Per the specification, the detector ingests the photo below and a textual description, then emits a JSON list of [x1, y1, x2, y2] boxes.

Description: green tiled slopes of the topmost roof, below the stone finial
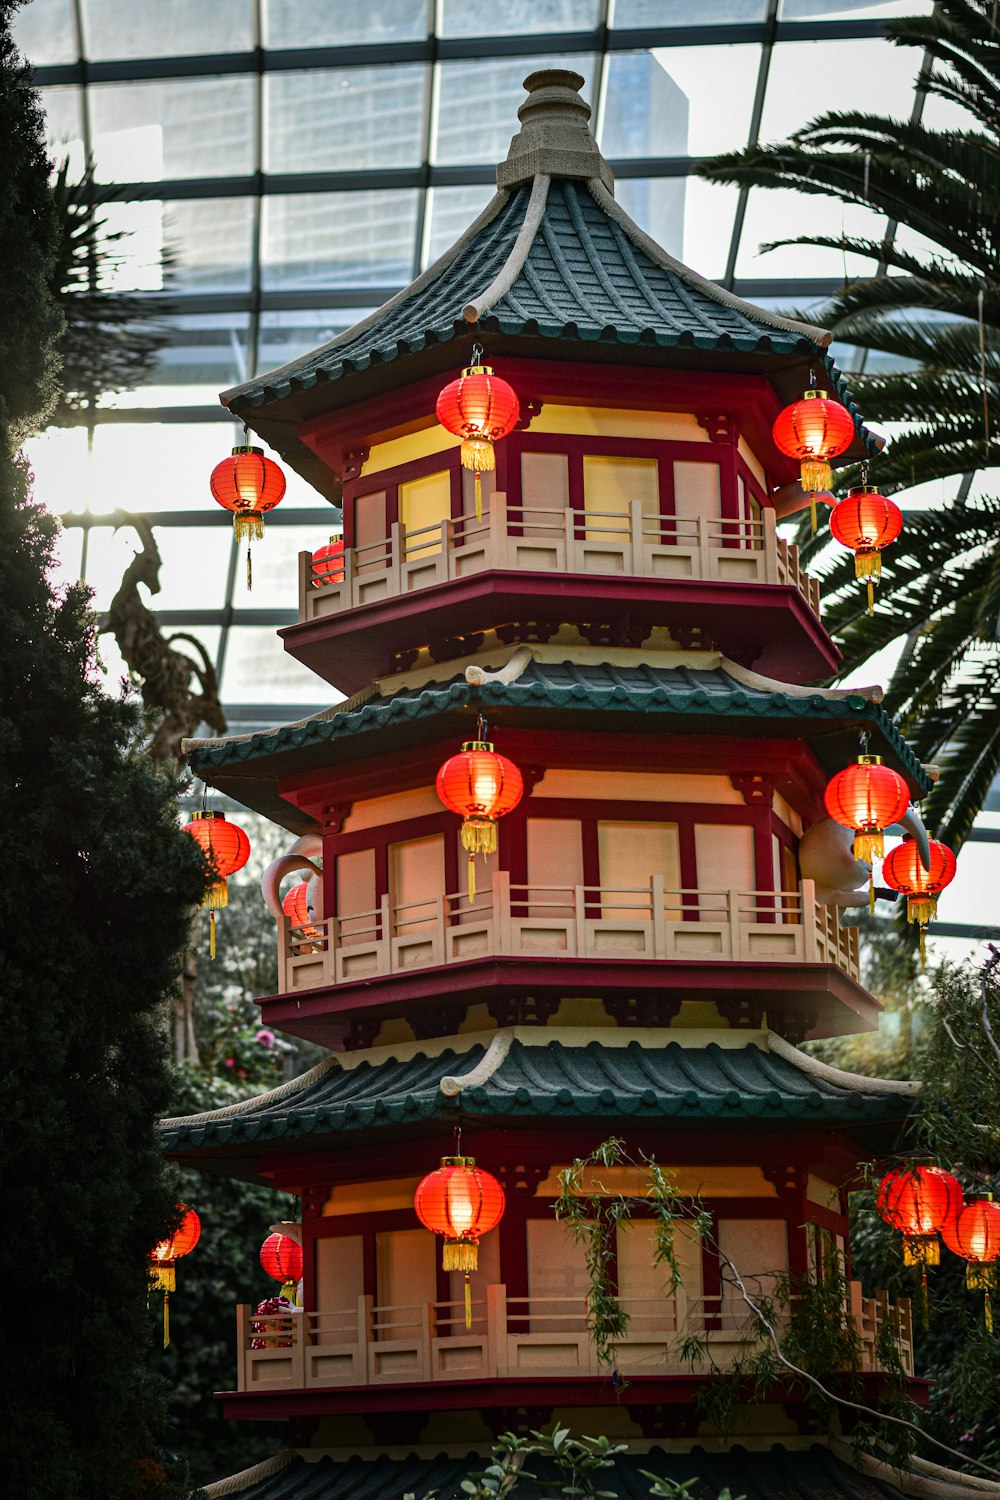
[[222, 180, 861, 431]]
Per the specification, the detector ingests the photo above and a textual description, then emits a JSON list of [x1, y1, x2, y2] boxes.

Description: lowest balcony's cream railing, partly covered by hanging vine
[[237, 1281, 913, 1391]]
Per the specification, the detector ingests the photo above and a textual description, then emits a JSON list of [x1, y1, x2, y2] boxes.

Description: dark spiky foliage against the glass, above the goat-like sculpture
[[51, 162, 169, 425]]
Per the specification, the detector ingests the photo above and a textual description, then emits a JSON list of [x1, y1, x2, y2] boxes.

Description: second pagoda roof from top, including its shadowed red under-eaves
[[184, 656, 931, 831]]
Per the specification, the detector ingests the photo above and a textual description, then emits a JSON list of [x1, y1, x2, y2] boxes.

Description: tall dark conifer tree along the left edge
[[0, 0, 204, 1500]]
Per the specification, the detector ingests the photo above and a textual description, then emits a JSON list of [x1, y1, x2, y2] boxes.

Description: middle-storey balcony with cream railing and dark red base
[[261, 870, 879, 1047]]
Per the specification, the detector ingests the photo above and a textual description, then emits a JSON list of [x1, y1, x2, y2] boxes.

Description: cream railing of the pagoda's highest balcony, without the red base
[[298, 494, 820, 624]]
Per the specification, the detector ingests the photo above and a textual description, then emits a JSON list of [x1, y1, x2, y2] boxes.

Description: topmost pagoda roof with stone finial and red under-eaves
[[220, 69, 867, 498]]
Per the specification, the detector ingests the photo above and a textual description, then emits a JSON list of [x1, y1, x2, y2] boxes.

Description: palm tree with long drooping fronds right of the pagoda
[[700, 0, 1000, 848]]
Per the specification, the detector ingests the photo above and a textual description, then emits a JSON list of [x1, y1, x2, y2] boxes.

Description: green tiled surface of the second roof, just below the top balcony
[[189, 662, 930, 792]]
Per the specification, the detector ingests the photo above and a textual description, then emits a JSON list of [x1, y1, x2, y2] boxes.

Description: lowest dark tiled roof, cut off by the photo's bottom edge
[[207, 1443, 917, 1500]]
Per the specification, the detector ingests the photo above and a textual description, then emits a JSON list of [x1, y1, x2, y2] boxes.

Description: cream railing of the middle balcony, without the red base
[[279, 870, 861, 995]]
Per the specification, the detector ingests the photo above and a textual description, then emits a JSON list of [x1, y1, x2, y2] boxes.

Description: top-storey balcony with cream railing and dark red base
[[283, 494, 838, 692]]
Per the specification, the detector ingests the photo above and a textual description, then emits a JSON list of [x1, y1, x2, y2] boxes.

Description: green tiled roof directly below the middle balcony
[[162, 1041, 910, 1154]]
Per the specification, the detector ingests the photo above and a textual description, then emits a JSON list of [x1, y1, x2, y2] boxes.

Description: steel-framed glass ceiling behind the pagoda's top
[[15, 0, 930, 731]]
